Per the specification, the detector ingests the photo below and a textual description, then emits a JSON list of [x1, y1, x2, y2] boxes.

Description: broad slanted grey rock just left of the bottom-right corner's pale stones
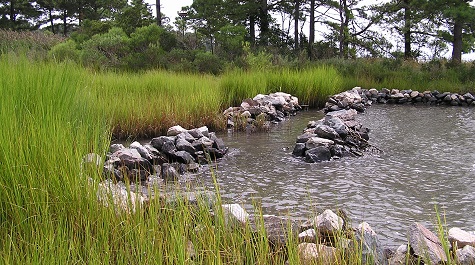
[[409, 223, 447, 264]]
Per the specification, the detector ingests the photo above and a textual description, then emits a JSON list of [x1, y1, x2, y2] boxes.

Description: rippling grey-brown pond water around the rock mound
[[208, 105, 475, 247]]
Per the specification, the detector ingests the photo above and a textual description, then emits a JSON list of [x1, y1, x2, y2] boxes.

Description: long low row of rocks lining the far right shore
[[324, 87, 475, 112]]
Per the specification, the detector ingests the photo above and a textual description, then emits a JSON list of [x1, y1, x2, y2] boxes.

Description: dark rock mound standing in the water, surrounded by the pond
[[292, 109, 370, 163]]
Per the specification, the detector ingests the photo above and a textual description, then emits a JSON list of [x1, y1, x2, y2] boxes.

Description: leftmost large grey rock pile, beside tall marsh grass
[[104, 125, 228, 182]]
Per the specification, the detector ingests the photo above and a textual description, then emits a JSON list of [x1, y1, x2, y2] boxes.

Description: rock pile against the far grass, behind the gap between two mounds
[[223, 92, 302, 130]]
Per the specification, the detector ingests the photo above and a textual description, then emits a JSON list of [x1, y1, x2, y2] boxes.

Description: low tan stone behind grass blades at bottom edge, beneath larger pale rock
[[297, 243, 337, 265]]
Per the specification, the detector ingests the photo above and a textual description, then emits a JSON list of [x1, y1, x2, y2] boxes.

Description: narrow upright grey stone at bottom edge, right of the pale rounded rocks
[[355, 222, 388, 265]]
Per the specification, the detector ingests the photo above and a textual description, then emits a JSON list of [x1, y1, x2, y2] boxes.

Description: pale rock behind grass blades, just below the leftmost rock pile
[[97, 180, 147, 214]]
